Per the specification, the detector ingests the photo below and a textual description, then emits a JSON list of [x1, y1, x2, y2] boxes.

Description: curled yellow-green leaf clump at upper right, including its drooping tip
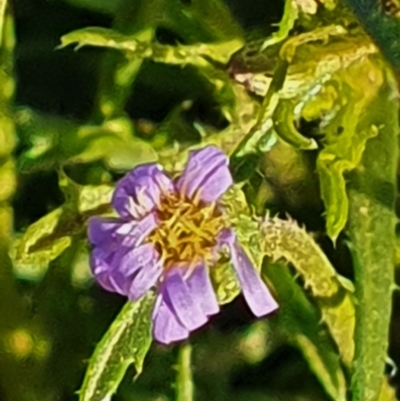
[[236, 25, 382, 241]]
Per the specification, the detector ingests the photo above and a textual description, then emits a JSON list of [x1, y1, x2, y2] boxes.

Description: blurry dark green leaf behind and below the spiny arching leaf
[[262, 263, 347, 401]]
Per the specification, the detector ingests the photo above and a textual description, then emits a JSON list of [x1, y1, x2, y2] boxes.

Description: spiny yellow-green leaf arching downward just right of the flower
[[261, 217, 355, 366]]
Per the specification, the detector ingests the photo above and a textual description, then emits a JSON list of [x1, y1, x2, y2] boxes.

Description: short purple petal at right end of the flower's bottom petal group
[[186, 266, 219, 316]]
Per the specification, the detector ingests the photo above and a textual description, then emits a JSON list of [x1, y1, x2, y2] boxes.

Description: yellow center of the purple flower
[[148, 194, 225, 270]]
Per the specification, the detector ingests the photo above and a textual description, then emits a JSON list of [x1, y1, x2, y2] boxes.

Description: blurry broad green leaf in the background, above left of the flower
[[16, 108, 157, 172]]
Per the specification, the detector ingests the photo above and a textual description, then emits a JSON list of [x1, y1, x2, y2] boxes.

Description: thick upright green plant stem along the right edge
[[348, 66, 399, 401]]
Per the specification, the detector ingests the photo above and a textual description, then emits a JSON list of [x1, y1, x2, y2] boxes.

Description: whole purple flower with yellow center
[[89, 146, 277, 344]]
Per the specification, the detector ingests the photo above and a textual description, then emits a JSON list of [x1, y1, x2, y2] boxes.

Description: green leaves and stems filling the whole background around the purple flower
[[0, 0, 399, 401]]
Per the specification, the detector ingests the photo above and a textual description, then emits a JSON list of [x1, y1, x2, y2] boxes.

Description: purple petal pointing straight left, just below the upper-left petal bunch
[[88, 213, 157, 250]]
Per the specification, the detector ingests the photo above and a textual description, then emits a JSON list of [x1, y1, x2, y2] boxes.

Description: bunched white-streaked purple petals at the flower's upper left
[[112, 163, 174, 219]]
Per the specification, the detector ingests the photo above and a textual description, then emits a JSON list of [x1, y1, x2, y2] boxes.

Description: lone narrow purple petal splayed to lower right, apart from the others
[[220, 230, 278, 317]]
